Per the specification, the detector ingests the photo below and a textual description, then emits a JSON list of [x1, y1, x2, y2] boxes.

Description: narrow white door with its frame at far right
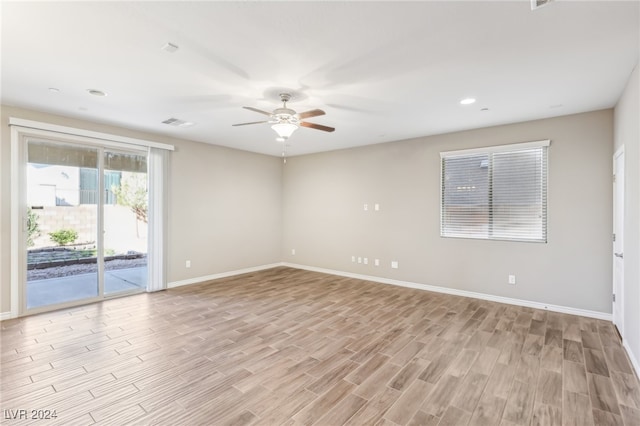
[[611, 145, 625, 337]]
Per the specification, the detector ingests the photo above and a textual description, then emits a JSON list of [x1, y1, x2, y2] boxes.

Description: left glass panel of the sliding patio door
[[26, 141, 100, 309]]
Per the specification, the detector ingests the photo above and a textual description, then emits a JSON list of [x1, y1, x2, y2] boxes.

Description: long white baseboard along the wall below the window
[[283, 262, 612, 321]]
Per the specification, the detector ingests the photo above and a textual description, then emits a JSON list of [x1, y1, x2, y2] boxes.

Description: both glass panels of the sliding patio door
[[23, 139, 148, 311]]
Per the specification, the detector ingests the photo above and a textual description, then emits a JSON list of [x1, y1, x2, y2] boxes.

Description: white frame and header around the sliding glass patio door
[[9, 118, 160, 318]]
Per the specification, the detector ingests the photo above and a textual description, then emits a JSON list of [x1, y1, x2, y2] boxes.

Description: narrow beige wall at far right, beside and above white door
[[614, 65, 640, 373]]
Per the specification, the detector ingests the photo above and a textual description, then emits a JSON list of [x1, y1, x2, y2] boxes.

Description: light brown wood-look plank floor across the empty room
[[0, 268, 640, 426]]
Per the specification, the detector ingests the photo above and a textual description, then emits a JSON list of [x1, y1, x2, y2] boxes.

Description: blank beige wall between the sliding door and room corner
[[167, 136, 282, 281]]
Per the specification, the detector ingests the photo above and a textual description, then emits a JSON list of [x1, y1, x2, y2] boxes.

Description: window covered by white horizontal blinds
[[440, 140, 550, 242]]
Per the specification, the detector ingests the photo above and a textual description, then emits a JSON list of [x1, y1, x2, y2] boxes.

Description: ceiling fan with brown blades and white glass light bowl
[[234, 93, 335, 142]]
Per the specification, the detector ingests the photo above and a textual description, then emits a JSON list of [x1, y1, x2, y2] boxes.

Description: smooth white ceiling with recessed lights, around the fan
[[1, 0, 640, 155]]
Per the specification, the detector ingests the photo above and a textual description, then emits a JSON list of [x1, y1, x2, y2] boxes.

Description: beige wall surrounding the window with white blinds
[[283, 110, 613, 313]]
